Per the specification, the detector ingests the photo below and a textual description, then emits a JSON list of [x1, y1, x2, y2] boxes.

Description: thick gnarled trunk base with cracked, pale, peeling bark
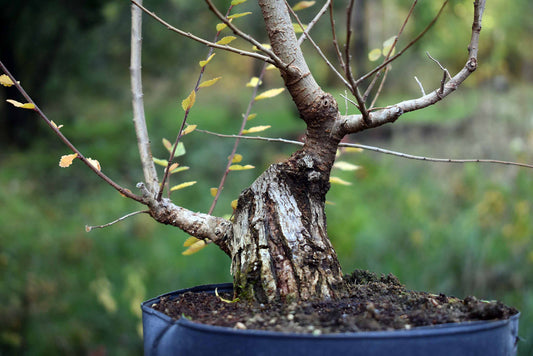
[[229, 140, 343, 302]]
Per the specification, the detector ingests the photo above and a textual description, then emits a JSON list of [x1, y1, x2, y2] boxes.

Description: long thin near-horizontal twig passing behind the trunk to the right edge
[[195, 129, 533, 169]]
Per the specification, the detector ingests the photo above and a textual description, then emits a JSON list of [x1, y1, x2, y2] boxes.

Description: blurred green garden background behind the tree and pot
[[0, 0, 533, 355]]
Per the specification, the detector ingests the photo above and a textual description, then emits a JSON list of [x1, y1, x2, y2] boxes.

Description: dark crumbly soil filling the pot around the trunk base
[[152, 271, 518, 334]]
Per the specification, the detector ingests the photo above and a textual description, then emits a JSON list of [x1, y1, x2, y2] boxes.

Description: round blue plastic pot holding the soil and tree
[[141, 284, 519, 356]]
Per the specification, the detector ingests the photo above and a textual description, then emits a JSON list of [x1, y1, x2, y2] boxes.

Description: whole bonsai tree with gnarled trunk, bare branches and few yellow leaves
[[4, 0, 520, 302]]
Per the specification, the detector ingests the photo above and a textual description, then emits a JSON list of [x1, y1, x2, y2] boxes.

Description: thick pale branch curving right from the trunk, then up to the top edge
[[335, 0, 485, 135]]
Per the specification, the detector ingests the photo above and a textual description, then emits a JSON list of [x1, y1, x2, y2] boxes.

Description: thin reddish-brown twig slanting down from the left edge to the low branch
[[0, 61, 143, 203]]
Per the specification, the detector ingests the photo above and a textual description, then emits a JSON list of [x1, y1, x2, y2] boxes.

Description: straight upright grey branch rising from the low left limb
[[130, 0, 158, 193]]
